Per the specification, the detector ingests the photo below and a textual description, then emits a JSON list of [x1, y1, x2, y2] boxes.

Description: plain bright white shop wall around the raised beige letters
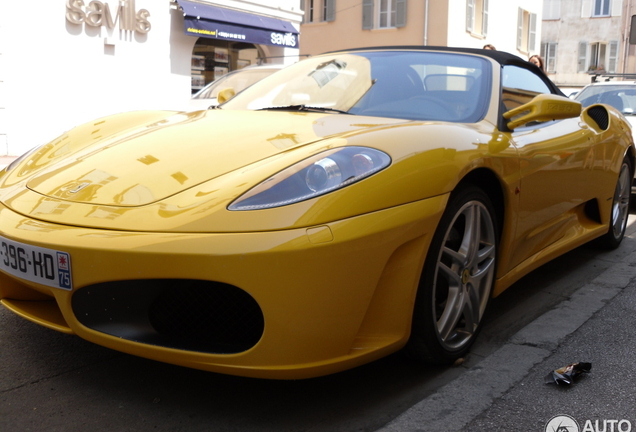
[[0, 0, 301, 155]]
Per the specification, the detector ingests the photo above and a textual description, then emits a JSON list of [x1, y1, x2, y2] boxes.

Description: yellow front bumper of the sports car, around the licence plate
[[0, 195, 447, 379]]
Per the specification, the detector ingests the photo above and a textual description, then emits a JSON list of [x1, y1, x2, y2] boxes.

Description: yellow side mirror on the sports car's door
[[504, 94, 582, 130]]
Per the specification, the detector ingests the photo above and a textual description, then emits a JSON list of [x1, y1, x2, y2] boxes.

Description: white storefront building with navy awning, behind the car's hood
[[0, 0, 303, 155]]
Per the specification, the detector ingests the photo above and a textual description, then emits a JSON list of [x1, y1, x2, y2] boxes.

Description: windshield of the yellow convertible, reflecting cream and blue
[[222, 51, 491, 122]]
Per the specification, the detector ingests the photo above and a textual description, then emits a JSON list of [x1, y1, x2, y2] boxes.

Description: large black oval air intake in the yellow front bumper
[[72, 279, 264, 354]]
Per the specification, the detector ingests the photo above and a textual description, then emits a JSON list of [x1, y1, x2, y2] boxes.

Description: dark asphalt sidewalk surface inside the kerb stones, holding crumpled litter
[[461, 272, 636, 432]]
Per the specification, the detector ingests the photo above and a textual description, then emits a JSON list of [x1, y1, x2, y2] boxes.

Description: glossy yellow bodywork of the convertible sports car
[[0, 47, 634, 379]]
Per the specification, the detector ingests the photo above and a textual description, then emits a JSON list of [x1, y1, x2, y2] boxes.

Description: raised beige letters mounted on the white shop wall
[[66, 0, 152, 34]]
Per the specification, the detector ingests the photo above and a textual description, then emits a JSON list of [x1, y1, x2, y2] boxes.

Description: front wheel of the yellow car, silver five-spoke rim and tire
[[406, 186, 499, 364]]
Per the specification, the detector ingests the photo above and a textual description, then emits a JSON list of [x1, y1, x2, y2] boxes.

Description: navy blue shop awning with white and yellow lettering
[[177, 0, 299, 48]]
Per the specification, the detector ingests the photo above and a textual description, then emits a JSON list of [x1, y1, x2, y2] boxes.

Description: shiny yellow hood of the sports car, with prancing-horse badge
[[4, 110, 399, 207]]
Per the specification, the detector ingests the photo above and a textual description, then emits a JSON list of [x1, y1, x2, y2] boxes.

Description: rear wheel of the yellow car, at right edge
[[599, 156, 634, 249]]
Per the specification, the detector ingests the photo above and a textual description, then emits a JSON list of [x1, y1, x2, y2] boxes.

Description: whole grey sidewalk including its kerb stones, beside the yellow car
[[380, 226, 636, 432]]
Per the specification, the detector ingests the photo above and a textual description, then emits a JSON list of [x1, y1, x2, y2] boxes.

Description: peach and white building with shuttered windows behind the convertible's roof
[[300, 0, 542, 58]]
